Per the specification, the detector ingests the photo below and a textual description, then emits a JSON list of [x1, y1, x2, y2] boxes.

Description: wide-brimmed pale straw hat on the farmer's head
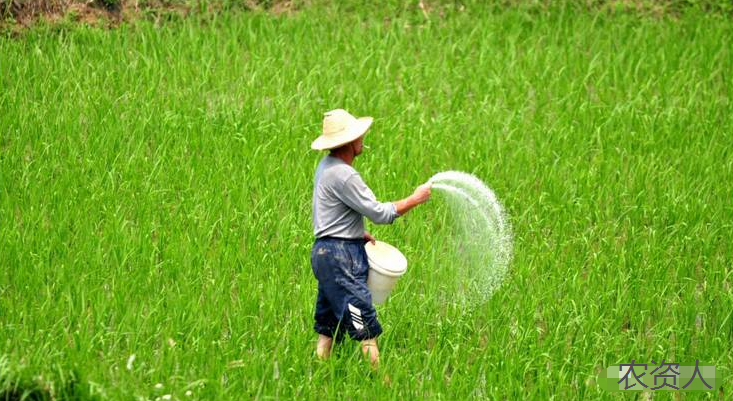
[[311, 109, 372, 150]]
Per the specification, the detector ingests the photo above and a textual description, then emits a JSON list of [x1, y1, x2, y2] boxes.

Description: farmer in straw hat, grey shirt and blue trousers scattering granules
[[311, 109, 431, 366]]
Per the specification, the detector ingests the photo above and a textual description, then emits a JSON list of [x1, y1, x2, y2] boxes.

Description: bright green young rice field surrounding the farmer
[[0, 3, 733, 400]]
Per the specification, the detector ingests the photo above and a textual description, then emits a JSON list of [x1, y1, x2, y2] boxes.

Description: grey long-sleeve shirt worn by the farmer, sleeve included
[[313, 156, 399, 238]]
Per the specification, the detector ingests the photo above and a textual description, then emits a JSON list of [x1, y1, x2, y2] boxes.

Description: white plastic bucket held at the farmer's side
[[364, 241, 407, 304]]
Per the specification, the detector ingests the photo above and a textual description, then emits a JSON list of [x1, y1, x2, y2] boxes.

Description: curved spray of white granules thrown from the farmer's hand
[[429, 171, 512, 299]]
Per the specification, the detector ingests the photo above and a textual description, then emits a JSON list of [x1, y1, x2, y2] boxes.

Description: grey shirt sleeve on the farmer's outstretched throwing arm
[[338, 173, 399, 224]]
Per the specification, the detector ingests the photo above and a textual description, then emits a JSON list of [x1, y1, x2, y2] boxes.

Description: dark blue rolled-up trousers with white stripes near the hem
[[311, 238, 382, 341]]
